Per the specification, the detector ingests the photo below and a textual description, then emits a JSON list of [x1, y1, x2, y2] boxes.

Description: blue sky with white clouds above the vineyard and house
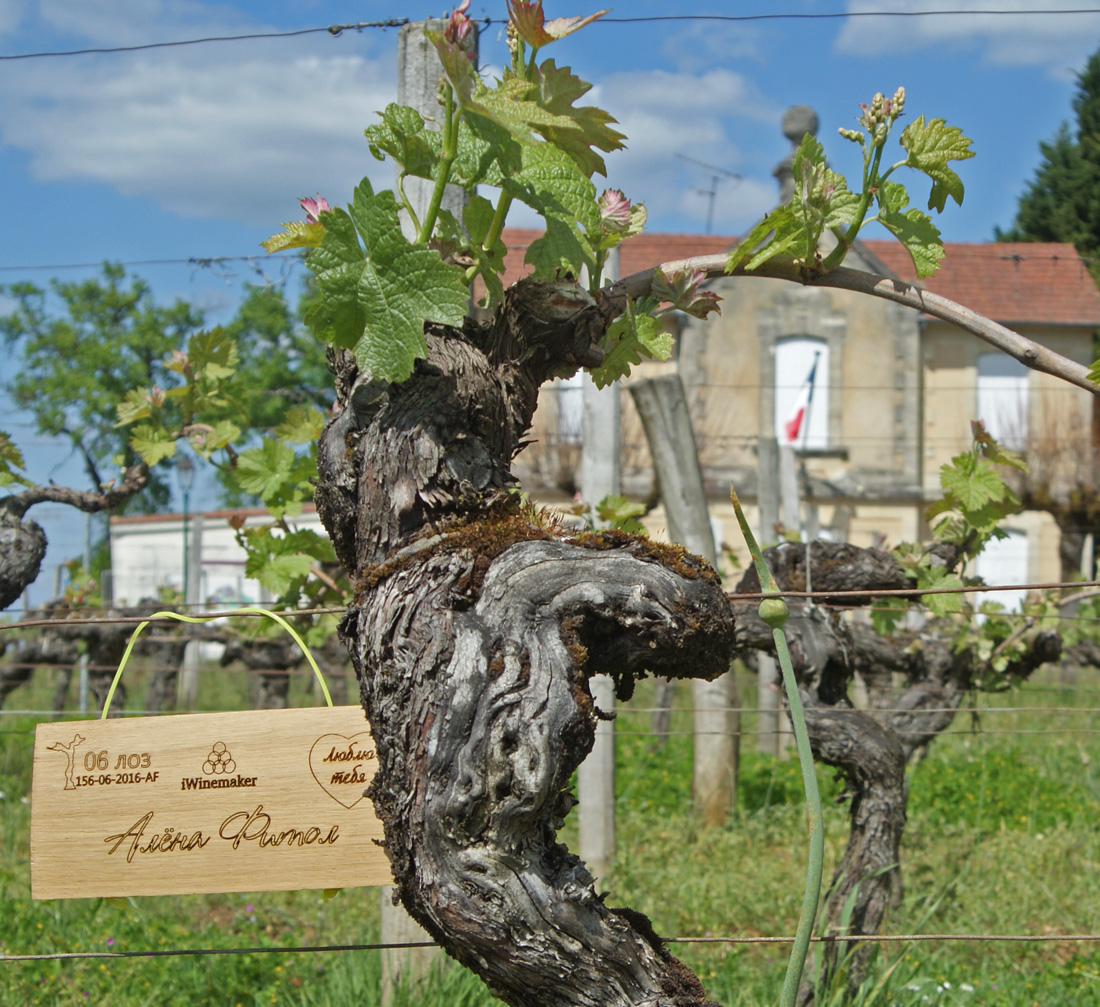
[[0, 0, 1100, 601]]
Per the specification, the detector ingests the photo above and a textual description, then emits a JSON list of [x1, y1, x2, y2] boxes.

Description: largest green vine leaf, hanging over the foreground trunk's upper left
[[306, 178, 469, 382]]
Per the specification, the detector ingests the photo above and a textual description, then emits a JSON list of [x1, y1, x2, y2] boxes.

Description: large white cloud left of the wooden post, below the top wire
[[0, 41, 396, 225]]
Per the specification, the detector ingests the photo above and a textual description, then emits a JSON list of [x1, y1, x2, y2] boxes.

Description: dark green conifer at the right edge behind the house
[[997, 42, 1100, 282]]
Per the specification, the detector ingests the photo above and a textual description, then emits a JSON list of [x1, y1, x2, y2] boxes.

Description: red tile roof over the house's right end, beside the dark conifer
[[860, 240, 1100, 326]]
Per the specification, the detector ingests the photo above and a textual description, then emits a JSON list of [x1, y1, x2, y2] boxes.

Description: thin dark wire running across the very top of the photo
[[0, 7, 1100, 61]]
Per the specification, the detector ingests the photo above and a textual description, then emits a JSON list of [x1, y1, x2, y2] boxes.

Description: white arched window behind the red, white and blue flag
[[776, 336, 829, 450]]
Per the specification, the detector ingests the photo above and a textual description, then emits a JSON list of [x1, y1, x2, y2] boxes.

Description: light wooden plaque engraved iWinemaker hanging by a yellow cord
[[31, 707, 393, 899]]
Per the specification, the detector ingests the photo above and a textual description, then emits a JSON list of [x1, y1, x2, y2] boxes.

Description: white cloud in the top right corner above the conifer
[[834, 0, 1100, 76]]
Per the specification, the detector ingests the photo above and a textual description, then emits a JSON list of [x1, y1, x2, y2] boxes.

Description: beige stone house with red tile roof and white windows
[[505, 234, 1100, 583]]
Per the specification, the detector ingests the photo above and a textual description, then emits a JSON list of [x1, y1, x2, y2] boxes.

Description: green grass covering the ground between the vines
[[0, 669, 1100, 1007]]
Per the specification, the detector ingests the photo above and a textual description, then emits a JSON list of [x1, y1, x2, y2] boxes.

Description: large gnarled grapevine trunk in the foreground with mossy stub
[[317, 281, 733, 1007]]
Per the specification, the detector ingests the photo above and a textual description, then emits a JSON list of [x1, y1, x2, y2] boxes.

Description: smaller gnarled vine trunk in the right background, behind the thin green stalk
[[734, 541, 1062, 1005]]
